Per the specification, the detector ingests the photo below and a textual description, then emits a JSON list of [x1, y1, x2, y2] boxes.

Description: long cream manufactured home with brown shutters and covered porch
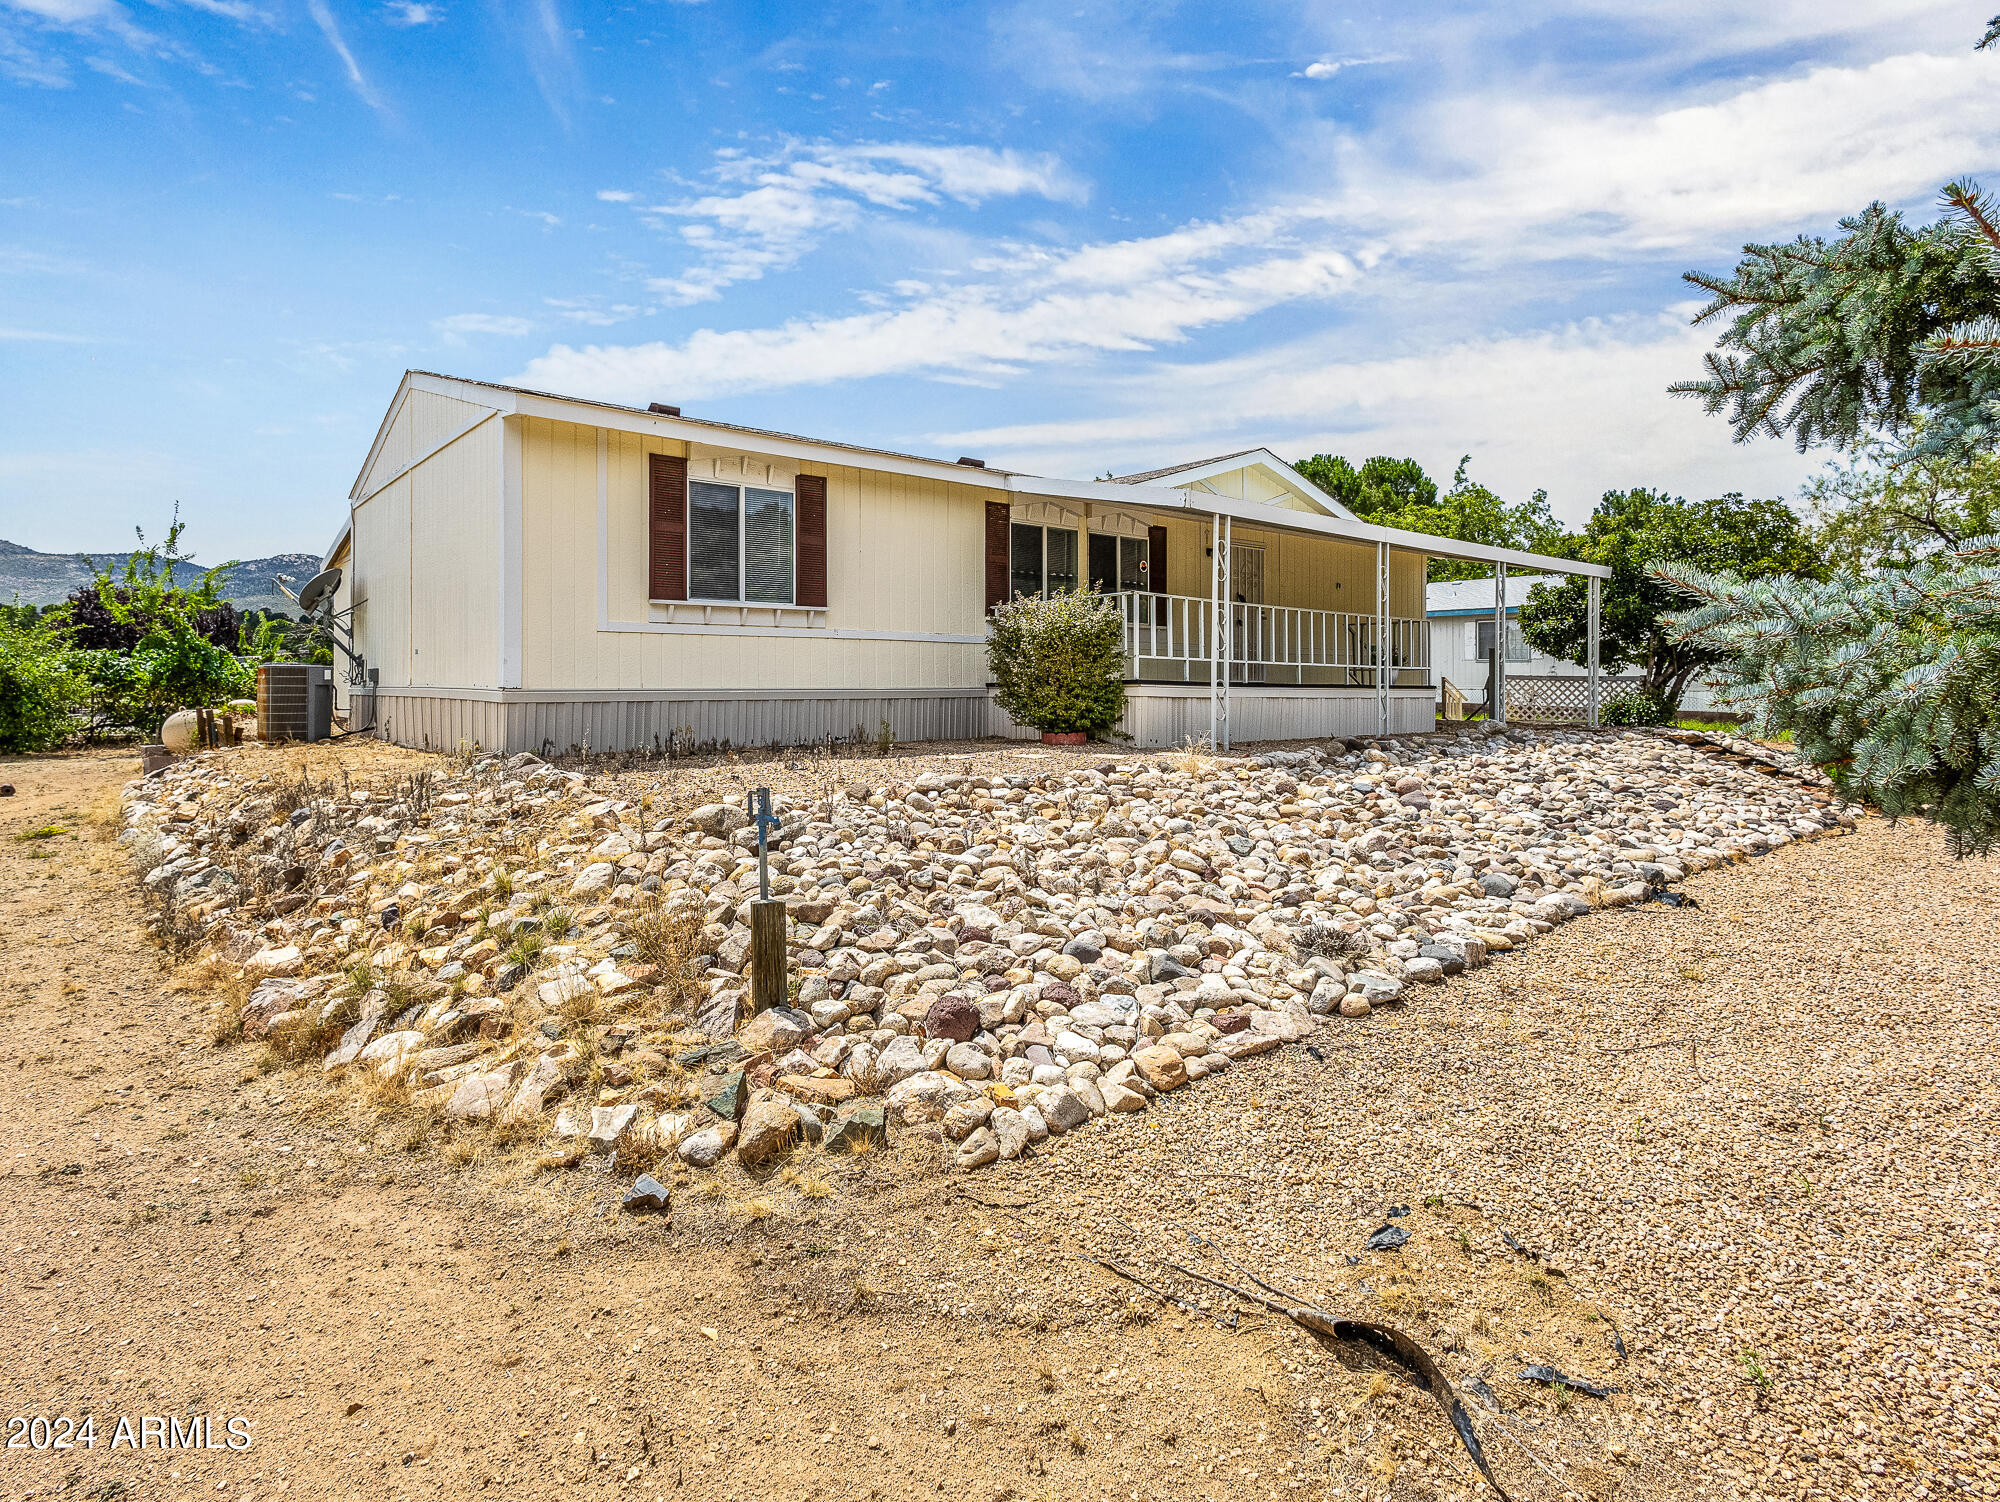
[[326, 370, 1604, 752]]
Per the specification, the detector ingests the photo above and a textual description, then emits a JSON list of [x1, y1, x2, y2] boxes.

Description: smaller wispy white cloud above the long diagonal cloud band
[[642, 142, 1090, 304]]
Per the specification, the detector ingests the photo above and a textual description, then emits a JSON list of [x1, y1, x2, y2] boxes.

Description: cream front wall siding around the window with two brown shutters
[[522, 418, 986, 692]]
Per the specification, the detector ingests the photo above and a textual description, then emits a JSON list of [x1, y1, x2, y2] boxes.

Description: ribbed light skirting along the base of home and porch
[[368, 684, 1436, 754]]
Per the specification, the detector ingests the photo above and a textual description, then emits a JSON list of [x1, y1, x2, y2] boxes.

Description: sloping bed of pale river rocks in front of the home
[[120, 730, 1854, 1184]]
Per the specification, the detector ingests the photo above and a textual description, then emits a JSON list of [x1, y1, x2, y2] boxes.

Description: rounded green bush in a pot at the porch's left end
[[986, 588, 1124, 738]]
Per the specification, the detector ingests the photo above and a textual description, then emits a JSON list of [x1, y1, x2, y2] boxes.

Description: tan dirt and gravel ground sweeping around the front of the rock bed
[[0, 754, 2000, 1502]]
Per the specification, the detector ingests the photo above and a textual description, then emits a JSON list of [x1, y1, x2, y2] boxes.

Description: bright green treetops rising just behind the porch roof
[[1292, 454, 1572, 580]]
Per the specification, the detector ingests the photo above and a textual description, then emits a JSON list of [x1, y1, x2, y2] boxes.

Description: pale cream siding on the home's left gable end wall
[[354, 418, 500, 688]]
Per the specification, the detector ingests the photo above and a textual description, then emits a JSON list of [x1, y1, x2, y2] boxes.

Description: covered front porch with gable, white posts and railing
[[1006, 450, 1608, 750]]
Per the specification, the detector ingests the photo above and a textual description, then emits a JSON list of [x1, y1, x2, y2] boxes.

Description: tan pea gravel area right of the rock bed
[[956, 820, 2000, 1498]]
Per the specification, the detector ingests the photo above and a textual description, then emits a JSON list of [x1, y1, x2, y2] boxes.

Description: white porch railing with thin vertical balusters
[[1104, 590, 1432, 688]]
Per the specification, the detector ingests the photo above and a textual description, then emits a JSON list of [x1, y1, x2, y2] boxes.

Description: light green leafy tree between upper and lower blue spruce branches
[[1804, 438, 2000, 574]]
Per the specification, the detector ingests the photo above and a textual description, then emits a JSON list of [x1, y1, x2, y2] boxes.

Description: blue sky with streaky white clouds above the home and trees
[[0, 0, 2000, 560]]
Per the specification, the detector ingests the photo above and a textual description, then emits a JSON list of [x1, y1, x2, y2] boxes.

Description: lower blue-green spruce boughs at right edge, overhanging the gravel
[[1658, 536, 2000, 856]]
